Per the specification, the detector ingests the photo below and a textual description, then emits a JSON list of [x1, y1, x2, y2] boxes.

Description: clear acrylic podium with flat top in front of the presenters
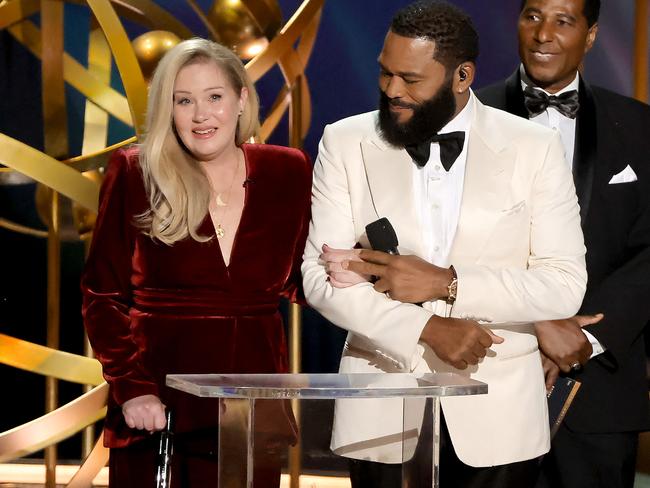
[[167, 373, 487, 488]]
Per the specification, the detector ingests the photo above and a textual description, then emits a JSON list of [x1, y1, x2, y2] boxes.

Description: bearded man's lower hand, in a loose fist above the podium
[[420, 315, 504, 369]]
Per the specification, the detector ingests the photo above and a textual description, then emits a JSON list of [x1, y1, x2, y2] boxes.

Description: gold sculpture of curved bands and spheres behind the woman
[[0, 0, 324, 487]]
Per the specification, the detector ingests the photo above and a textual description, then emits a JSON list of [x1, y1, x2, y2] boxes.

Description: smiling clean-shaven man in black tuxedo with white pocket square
[[478, 0, 650, 488]]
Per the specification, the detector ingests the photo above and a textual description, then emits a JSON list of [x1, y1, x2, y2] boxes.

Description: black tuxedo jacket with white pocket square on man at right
[[477, 70, 650, 433]]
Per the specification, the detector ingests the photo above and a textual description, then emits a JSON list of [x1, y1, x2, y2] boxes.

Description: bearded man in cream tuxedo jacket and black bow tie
[[303, 2, 586, 488]]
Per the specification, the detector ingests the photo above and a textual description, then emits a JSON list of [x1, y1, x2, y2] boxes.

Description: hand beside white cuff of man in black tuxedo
[[535, 313, 604, 373]]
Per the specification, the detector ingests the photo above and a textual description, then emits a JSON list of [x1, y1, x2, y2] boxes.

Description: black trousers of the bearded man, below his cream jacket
[[350, 407, 539, 488]]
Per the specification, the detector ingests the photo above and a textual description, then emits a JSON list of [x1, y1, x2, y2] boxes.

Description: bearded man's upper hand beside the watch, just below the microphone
[[341, 249, 453, 303]]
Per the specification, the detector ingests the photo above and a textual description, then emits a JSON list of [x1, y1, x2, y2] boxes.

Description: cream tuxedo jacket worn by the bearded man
[[302, 96, 587, 466]]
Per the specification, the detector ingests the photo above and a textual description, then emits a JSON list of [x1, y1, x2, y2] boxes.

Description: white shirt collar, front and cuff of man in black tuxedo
[[519, 65, 605, 358]]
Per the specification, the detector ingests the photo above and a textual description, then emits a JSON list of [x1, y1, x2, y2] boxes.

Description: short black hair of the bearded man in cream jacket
[[390, 0, 479, 70]]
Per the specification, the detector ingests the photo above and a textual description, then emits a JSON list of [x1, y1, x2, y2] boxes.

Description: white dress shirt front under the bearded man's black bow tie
[[413, 92, 475, 268]]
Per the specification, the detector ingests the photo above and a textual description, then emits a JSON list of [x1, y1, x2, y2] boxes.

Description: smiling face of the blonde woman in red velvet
[[173, 60, 248, 162]]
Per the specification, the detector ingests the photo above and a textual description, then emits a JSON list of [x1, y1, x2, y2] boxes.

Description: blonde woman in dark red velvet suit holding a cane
[[82, 39, 311, 488]]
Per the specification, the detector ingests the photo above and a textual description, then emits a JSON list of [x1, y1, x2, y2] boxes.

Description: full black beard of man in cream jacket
[[378, 77, 456, 147]]
